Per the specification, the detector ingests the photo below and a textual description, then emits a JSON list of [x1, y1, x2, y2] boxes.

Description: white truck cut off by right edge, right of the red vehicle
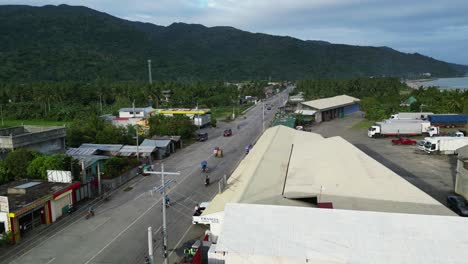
[[424, 137, 468, 155]]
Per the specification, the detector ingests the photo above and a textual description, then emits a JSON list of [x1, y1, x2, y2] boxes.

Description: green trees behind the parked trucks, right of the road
[[295, 78, 468, 120]]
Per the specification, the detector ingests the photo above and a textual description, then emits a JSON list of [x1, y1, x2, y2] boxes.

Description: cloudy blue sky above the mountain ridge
[[0, 0, 468, 65]]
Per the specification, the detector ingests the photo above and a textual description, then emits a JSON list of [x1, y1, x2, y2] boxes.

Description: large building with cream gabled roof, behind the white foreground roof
[[200, 126, 455, 236]]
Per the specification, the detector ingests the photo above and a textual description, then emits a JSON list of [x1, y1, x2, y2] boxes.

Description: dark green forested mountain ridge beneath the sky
[[0, 5, 468, 82]]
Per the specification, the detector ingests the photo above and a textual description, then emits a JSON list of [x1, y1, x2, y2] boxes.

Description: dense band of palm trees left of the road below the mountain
[[0, 80, 267, 121]]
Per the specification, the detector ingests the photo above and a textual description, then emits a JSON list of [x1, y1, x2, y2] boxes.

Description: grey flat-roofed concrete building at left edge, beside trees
[[0, 126, 66, 154]]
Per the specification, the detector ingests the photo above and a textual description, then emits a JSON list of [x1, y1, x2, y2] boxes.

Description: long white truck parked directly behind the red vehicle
[[367, 119, 439, 138]]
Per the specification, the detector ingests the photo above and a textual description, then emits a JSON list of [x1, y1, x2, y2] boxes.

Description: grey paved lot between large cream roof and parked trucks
[[311, 113, 456, 207]]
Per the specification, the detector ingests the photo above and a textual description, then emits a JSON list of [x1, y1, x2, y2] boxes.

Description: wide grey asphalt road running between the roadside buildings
[[1, 88, 286, 264]]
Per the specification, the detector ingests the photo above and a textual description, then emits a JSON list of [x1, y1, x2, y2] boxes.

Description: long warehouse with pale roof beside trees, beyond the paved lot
[[297, 95, 360, 123]]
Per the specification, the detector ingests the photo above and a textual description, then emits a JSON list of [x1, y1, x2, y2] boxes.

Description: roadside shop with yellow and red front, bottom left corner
[[0, 181, 80, 242]]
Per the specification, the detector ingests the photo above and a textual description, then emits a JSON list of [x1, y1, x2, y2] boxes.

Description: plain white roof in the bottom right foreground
[[213, 204, 468, 264]]
